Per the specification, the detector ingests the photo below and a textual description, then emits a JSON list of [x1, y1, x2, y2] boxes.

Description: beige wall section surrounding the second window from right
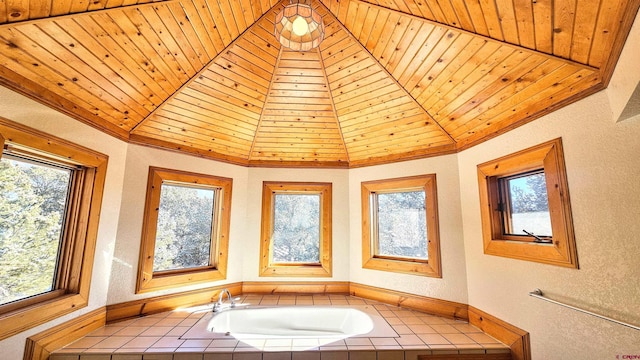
[[349, 155, 467, 304]]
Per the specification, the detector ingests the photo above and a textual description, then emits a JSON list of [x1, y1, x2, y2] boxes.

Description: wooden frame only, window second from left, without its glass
[[136, 167, 233, 294]]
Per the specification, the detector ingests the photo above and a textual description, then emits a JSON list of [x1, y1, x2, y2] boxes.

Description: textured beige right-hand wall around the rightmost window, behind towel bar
[[458, 12, 640, 359]]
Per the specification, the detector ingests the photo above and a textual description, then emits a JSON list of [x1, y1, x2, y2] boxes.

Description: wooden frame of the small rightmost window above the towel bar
[[478, 138, 578, 269]]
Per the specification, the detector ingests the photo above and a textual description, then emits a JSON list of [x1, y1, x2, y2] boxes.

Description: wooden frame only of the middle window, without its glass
[[259, 181, 332, 277]]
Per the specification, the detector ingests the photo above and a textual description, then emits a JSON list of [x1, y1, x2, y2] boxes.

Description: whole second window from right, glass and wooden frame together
[[362, 174, 442, 277]]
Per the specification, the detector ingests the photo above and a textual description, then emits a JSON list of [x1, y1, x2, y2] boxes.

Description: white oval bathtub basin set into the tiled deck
[[206, 306, 374, 338]]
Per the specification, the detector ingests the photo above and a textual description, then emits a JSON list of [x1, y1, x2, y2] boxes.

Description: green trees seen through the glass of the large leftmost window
[[0, 154, 71, 304]]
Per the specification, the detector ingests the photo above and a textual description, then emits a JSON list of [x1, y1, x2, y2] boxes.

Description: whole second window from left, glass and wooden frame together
[[136, 167, 232, 293]]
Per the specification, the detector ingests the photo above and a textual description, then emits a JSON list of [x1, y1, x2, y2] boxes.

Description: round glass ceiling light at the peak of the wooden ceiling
[[275, 0, 324, 51]]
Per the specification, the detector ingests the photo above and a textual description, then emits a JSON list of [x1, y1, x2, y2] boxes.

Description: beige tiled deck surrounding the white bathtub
[[51, 294, 510, 360]]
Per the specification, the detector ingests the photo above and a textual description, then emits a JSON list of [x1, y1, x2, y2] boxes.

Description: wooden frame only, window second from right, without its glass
[[361, 174, 442, 278]]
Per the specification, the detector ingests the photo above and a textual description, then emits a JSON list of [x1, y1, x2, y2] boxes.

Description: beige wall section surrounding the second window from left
[[107, 145, 248, 304]]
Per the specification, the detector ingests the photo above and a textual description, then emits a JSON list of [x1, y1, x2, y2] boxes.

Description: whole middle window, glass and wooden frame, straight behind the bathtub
[[260, 182, 331, 276]]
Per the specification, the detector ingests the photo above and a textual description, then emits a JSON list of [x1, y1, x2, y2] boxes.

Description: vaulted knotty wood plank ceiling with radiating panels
[[0, 0, 640, 167]]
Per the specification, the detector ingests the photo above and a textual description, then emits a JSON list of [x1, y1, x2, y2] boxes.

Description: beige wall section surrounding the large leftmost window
[[0, 87, 127, 360]]
